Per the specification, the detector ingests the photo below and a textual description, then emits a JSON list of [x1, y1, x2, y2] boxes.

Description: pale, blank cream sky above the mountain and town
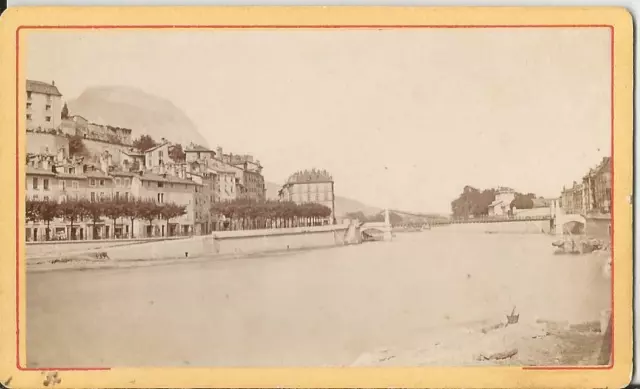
[[26, 28, 611, 213]]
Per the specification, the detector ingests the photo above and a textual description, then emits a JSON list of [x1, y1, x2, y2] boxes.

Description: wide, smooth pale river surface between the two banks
[[26, 228, 610, 367]]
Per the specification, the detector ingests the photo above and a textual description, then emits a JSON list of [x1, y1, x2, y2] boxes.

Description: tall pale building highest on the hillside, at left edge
[[26, 80, 62, 130]]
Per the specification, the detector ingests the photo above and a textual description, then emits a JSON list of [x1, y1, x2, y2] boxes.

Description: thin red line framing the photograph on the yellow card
[[15, 24, 615, 371]]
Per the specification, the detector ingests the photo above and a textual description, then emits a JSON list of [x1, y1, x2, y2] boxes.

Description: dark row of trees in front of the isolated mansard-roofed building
[[211, 199, 331, 229]]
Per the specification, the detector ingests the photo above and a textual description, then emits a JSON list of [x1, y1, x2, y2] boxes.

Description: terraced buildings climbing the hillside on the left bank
[[24, 82, 264, 240]]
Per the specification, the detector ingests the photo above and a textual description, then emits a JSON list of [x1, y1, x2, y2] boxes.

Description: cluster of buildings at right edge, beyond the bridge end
[[560, 157, 612, 215]]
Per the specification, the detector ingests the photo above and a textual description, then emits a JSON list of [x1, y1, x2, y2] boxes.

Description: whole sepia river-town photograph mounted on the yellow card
[[23, 26, 617, 368]]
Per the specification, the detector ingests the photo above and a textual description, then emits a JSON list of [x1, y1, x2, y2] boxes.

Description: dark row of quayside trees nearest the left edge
[[25, 199, 187, 240]]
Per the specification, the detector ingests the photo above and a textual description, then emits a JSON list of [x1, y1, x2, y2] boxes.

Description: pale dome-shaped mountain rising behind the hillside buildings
[[67, 86, 208, 147]]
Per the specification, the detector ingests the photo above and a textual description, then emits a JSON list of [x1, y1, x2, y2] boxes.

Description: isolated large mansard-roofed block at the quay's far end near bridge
[[279, 169, 335, 222]]
